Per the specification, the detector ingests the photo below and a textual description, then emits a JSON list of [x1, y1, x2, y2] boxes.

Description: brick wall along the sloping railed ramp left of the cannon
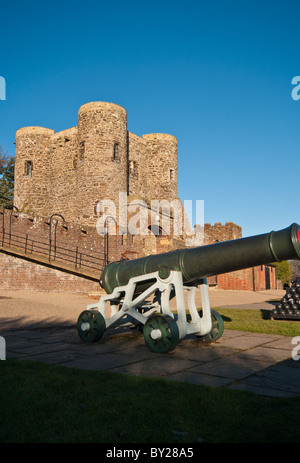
[[0, 210, 188, 293]]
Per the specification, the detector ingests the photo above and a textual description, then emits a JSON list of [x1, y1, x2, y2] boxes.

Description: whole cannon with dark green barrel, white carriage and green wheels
[[77, 223, 300, 353]]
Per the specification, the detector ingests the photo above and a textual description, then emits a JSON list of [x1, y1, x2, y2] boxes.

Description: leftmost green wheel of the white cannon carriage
[[77, 310, 105, 342]]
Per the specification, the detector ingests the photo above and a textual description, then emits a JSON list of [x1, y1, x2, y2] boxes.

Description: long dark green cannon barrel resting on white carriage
[[100, 223, 300, 294]]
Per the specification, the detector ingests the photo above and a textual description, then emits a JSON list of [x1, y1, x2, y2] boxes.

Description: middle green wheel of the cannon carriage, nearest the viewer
[[144, 314, 179, 354]]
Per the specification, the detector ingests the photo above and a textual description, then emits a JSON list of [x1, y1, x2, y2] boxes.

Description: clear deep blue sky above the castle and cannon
[[0, 0, 300, 236]]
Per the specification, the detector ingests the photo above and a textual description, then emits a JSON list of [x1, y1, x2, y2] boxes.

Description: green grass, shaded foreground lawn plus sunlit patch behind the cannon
[[0, 309, 300, 444]]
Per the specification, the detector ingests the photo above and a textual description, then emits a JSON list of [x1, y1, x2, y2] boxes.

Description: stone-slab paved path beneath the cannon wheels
[[0, 286, 300, 397]]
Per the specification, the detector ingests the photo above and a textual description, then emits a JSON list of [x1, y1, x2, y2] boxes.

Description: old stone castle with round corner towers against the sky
[[14, 102, 182, 234]]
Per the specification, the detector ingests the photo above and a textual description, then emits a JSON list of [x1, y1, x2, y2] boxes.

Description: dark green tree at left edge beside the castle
[[0, 146, 15, 207]]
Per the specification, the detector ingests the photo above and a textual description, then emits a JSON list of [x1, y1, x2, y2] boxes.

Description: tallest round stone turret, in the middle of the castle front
[[77, 102, 127, 228]]
